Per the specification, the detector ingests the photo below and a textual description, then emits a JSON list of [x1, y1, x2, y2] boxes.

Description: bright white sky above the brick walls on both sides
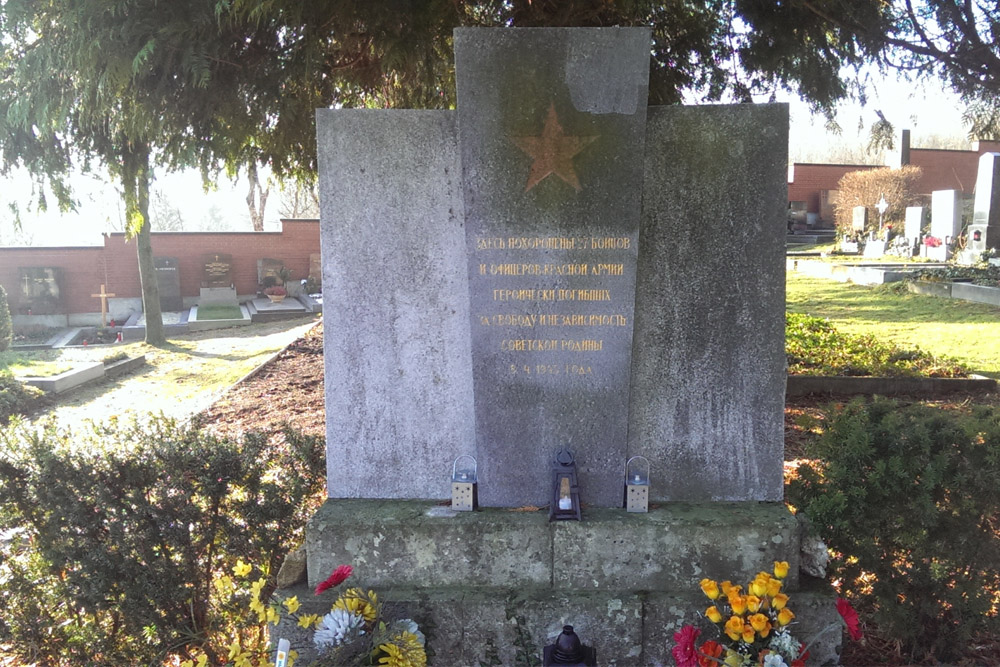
[[0, 69, 965, 246]]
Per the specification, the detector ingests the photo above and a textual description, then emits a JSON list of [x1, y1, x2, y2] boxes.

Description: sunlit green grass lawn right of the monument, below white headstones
[[786, 272, 1000, 378]]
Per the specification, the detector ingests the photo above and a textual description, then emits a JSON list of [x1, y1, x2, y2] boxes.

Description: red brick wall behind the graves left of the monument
[[0, 220, 320, 313]]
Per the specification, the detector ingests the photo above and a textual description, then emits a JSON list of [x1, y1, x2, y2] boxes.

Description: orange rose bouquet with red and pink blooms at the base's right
[[673, 561, 861, 667]]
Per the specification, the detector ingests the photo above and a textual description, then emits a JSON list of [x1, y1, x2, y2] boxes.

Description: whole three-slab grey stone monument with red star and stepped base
[[300, 28, 836, 665]]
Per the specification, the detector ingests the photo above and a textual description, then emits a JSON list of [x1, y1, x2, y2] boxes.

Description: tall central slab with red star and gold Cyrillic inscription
[[455, 28, 650, 506]]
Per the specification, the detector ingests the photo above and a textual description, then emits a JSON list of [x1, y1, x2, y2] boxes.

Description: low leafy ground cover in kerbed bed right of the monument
[[785, 313, 969, 377]]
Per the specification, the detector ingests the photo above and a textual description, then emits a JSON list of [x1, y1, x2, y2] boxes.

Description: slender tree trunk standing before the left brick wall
[[122, 145, 167, 345]]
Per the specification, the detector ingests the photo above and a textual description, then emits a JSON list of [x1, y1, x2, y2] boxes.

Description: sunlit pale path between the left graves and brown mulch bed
[[30, 319, 322, 426]]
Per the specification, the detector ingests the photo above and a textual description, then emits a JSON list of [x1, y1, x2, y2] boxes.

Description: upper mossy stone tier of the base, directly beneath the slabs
[[306, 500, 799, 591]]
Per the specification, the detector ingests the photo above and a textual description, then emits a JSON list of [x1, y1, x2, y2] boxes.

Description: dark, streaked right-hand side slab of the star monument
[[627, 104, 788, 502]]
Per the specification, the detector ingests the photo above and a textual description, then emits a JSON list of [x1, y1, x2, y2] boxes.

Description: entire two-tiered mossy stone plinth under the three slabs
[[286, 500, 840, 666]]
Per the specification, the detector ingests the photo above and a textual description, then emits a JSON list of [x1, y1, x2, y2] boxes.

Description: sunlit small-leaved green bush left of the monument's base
[[0, 419, 324, 665]]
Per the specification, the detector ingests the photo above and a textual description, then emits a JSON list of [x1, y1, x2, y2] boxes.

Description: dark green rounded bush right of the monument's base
[[786, 399, 1000, 662]]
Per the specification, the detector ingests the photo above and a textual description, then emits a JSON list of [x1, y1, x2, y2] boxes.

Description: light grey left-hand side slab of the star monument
[[316, 109, 475, 498]]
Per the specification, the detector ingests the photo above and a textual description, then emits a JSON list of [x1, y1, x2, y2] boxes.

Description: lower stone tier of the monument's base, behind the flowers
[[274, 574, 841, 667]]
